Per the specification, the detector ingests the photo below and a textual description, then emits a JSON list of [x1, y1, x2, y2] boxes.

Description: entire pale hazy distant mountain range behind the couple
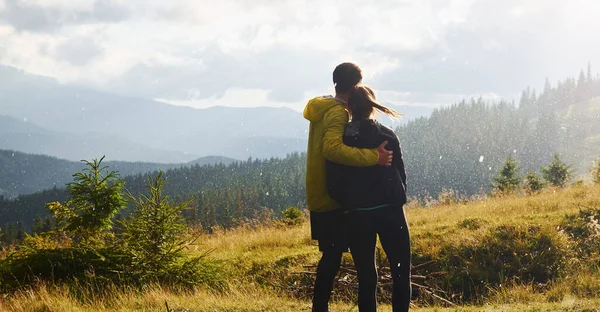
[[0, 65, 432, 163]]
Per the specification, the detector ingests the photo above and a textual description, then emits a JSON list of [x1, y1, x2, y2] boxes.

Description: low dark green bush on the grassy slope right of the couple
[[436, 222, 570, 301]]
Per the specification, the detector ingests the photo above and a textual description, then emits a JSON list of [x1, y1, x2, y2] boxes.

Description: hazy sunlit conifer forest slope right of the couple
[[396, 66, 600, 197]]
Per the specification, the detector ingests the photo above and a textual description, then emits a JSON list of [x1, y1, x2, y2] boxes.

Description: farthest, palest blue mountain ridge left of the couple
[[0, 66, 308, 160]]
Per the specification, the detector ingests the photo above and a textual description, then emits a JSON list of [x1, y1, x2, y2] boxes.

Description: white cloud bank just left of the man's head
[[111, 46, 336, 102]]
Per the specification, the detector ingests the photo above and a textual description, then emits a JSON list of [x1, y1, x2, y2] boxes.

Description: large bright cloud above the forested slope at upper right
[[376, 1, 600, 97]]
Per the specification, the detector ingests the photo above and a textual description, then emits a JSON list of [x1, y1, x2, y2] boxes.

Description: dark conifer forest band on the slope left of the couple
[[0, 153, 306, 240]]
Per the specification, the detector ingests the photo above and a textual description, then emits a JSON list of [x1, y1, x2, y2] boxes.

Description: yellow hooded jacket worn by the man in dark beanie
[[304, 96, 379, 212]]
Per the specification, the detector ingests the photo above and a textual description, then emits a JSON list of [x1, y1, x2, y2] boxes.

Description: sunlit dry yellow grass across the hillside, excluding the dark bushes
[[0, 185, 600, 311]]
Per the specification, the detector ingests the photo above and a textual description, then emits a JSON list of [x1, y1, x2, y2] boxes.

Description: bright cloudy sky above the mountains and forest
[[0, 0, 600, 110]]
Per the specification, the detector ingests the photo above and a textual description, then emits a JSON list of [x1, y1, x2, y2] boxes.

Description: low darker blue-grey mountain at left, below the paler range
[[0, 150, 236, 197]]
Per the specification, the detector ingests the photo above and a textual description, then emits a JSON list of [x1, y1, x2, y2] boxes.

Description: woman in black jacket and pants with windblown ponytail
[[327, 85, 411, 312]]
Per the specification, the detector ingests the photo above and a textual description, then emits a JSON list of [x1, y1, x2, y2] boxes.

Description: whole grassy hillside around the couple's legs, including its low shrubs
[[0, 184, 600, 311]]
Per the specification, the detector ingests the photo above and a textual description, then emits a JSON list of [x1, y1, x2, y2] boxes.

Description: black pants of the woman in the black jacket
[[347, 205, 411, 312]]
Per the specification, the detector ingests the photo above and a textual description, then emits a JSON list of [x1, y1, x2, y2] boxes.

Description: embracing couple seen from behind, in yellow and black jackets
[[304, 63, 411, 312]]
